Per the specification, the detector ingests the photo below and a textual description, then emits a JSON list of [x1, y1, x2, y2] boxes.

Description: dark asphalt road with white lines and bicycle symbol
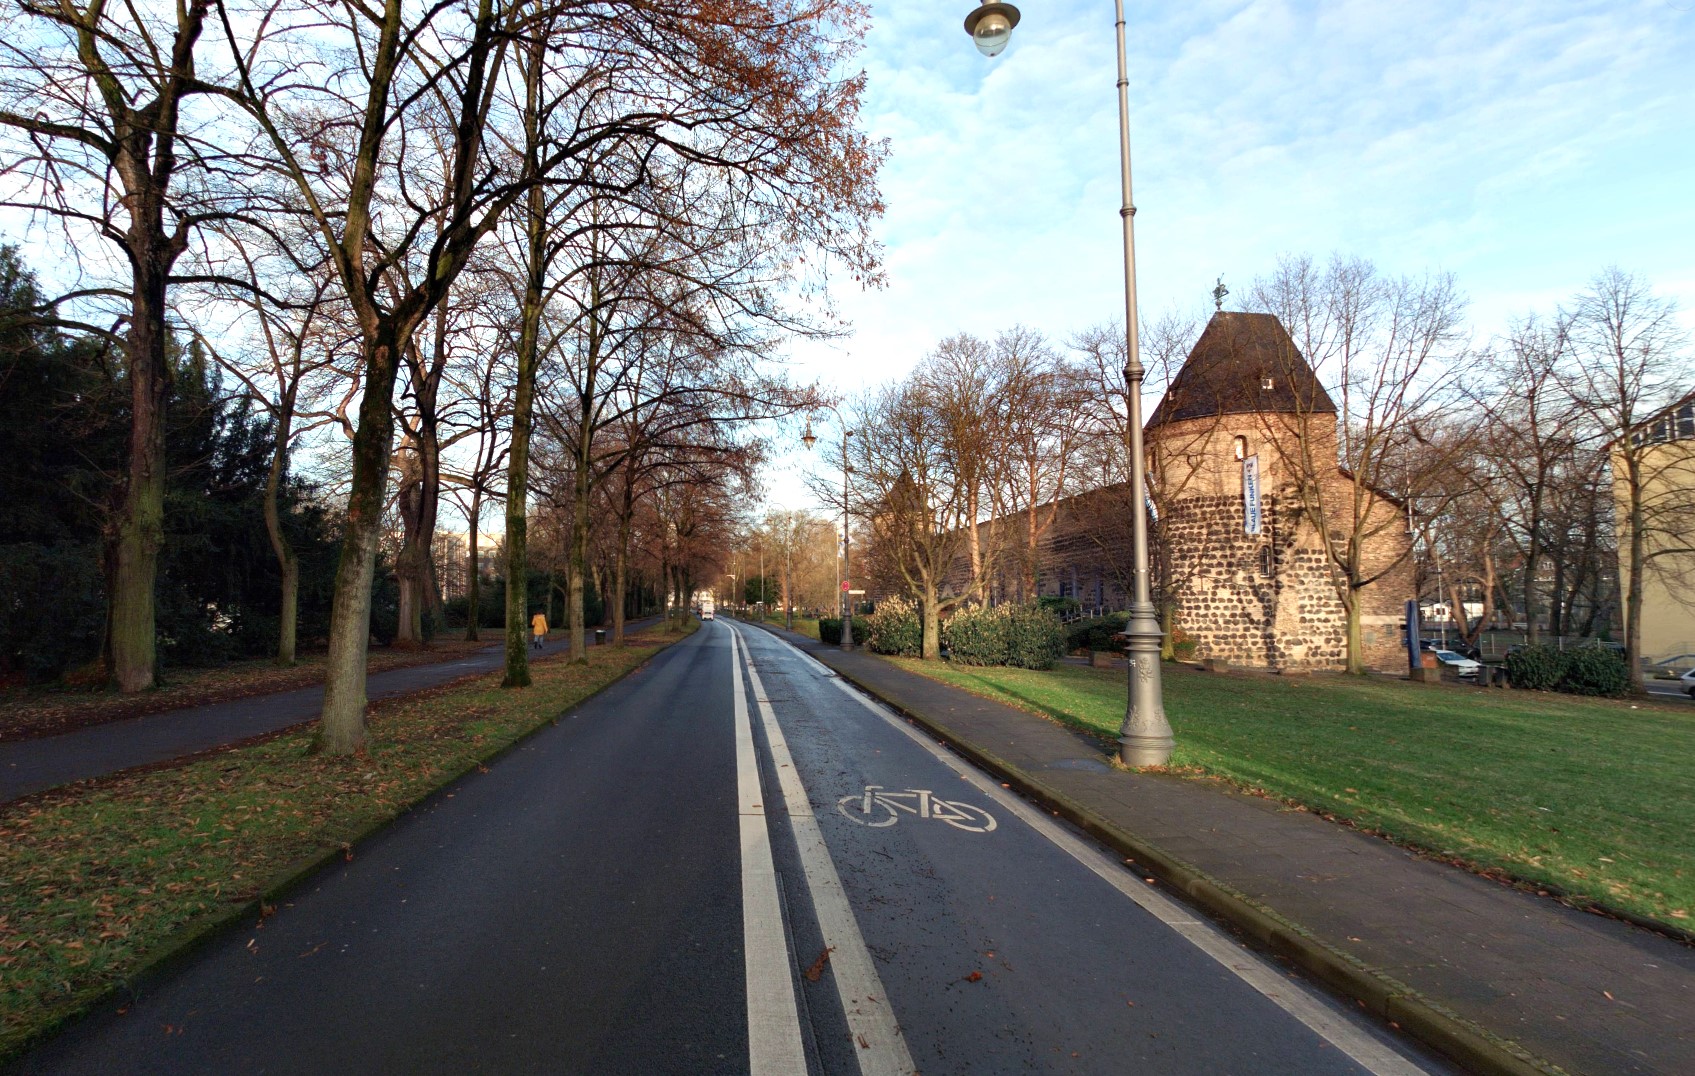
[[6, 620, 1442, 1076]]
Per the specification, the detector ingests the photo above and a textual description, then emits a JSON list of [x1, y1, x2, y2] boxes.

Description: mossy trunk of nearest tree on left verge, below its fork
[[317, 330, 410, 754]]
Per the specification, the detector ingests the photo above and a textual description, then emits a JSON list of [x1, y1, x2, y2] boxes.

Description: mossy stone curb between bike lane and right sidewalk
[[786, 640, 1564, 1076]]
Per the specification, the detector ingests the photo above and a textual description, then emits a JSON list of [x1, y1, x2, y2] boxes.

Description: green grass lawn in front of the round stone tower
[[897, 659, 1695, 930]]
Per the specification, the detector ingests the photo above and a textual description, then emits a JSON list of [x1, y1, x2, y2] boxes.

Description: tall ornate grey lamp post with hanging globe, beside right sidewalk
[[964, 0, 1171, 766]]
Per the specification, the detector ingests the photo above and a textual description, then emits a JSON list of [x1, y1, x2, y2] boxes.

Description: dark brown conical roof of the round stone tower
[[1148, 310, 1336, 429]]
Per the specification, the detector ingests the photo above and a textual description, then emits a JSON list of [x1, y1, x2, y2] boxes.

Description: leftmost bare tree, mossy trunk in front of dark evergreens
[[0, 0, 242, 691]]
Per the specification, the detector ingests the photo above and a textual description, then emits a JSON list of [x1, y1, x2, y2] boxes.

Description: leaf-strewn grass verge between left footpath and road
[[0, 624, 695, 1059]]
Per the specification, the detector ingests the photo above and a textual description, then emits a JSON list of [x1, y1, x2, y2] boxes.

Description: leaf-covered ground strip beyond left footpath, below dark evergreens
[[0, 632, 502, 740]]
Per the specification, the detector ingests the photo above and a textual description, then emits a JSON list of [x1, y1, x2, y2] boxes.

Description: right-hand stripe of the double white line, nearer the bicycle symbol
[[734, 627, 915, 1076]]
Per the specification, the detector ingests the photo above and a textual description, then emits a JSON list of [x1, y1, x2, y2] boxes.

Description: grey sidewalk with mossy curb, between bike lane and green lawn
[[771, 629, 1695, 1076]]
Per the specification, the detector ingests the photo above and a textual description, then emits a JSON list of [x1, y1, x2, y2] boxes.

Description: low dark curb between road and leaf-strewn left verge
[[0, 632, 693, 1068]]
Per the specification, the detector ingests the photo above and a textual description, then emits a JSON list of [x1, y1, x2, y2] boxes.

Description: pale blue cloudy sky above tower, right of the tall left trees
[[770, 0, 1695, 507]]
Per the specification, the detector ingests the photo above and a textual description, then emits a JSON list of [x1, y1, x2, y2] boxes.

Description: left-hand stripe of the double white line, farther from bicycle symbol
[[731, 632, 807, 1076]]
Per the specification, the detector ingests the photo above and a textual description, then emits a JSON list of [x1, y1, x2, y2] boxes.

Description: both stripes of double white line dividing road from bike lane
[[731, 627, 914, 1076]]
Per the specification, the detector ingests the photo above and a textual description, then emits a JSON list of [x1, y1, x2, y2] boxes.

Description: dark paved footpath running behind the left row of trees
[[0, 620, 649, 803]]
